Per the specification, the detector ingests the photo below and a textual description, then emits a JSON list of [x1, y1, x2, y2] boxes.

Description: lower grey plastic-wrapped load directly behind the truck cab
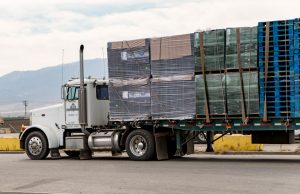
[[109, 83, 151, 121]]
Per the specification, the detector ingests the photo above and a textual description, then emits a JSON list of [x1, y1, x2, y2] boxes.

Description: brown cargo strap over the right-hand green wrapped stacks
[[236, 28, 247, 123]]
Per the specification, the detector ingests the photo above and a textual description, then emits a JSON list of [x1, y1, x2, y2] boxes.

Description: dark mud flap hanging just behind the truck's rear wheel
[[154, 133, 169, 160]]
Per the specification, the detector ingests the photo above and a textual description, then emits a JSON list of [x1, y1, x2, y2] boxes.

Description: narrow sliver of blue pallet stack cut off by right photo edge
[[294, 19, 300, 117]]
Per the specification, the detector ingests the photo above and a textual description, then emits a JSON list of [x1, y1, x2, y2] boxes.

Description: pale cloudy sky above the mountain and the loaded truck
[[0, 0, 300, 76]]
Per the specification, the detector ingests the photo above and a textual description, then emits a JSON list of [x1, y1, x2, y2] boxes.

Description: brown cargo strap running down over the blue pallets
[[263, 22, 270, 122]]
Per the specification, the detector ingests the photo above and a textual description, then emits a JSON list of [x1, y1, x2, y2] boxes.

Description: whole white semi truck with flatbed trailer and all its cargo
[[20, 19, 300, 161]]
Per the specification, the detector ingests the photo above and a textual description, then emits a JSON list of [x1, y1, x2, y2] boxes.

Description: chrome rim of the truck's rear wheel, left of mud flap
[[129, 135, 148, 156]]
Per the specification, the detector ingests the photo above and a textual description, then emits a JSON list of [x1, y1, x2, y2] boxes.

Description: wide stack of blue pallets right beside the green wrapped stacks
[[258, 20, 295, 117]]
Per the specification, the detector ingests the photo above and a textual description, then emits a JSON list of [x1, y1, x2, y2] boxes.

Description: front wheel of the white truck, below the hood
[[25, 131, 50, 160]]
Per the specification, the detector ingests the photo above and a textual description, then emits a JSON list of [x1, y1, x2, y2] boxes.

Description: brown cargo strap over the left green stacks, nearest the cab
[[199, 32, 210, 123]]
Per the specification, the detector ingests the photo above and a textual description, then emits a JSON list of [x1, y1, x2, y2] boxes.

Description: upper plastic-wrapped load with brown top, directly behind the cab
[[107, 39, 150, 80]]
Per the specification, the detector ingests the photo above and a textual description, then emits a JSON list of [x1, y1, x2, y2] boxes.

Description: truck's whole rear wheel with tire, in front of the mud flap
[[125, 129, 156, 161]]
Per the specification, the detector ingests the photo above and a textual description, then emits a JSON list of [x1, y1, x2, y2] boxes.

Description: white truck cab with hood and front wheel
[[20, 79, 109, 159]]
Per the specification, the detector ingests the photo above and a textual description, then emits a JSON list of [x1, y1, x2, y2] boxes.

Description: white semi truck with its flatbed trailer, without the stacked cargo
[[20, 45, 300, 161]]
